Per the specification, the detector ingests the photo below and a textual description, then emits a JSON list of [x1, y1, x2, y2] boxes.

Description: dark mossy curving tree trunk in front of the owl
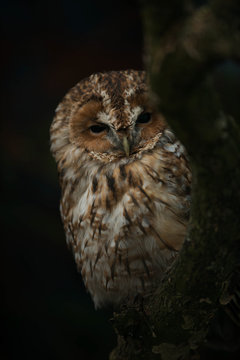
[[110, 0, 240, 360]]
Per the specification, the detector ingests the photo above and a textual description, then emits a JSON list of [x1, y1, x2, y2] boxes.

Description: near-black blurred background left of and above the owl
[[0, 0, 143, 360]]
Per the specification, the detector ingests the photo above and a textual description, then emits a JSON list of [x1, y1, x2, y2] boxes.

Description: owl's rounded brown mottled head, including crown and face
[[51, 70, 166, 165]]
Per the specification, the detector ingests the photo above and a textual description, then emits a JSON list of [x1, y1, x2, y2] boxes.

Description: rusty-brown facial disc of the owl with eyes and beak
[[69, 100, 165, 159]]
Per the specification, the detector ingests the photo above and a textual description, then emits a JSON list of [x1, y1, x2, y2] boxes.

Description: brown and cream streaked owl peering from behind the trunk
[[50, 70, 191, 308]]
